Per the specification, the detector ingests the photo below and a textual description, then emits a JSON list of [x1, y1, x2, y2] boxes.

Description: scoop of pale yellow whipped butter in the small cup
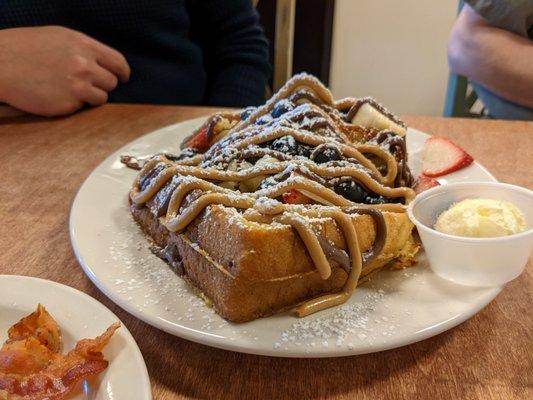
[[434, 199, 527, 238]]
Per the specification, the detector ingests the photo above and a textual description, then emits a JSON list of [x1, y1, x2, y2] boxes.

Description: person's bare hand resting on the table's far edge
[[0, 26, 130, 116]]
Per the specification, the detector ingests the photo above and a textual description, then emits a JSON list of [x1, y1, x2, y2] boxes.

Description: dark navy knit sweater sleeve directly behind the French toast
[[187, 0, 270, 107]]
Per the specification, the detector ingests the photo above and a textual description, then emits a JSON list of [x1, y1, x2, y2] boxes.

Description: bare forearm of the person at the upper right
[[448, 5, 533, 108]]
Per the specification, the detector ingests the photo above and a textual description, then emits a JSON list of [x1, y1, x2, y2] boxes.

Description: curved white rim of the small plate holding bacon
[[0, 274, 152, 400]]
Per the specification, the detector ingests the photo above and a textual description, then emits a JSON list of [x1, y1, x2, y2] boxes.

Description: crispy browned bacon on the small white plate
[[0, 304, 120, 400]]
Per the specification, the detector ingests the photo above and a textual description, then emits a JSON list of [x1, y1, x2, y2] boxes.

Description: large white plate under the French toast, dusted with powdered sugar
[[70, 118, 501, 357]]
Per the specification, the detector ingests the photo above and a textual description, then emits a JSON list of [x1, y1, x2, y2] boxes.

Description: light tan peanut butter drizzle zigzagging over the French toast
[[130, 76, 414, 317]]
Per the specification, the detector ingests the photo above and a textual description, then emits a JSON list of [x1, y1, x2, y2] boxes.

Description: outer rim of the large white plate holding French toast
[[69, 117, 503, 358]]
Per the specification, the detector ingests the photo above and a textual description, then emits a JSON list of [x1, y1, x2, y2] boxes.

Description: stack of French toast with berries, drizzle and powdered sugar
[[130, 74, 419, 322]]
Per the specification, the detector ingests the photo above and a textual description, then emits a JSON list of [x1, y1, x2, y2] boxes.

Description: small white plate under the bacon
[[0, 275, 152, 400]]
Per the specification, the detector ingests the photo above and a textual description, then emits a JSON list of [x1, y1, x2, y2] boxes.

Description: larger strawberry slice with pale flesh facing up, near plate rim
[[422, 136, 474, 177]]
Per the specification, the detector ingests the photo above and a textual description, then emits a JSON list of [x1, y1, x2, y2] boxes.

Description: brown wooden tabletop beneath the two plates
[[0, 105, 533, 400]]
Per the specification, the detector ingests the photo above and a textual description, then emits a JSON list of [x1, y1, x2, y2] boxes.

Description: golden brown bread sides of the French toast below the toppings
[[131, 205, 412, 322]]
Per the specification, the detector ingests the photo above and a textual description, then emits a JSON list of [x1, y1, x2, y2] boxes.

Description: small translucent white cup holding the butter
[[408, 182, 533, 286]]
